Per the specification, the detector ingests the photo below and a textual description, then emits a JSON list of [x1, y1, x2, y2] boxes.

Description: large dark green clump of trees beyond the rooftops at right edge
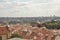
[[43, 21, 60, 29]]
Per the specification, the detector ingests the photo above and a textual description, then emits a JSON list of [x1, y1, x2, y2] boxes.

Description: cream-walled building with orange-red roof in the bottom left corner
[[0, 27, 9, 40]]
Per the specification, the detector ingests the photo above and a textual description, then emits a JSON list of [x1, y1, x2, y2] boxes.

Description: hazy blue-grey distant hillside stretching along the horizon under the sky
[[0, 17, 60, 23]]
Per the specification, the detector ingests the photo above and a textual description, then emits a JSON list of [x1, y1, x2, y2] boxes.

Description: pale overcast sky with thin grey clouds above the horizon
[[0, 0, 60, 17]]
